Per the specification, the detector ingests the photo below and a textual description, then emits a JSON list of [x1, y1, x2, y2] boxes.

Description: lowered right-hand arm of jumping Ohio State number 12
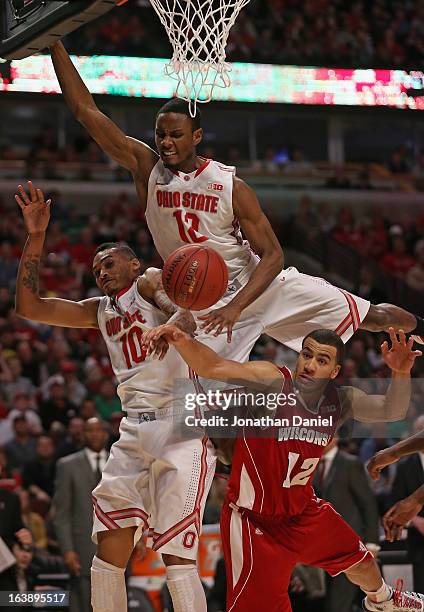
[[199, 177, 284, 342]]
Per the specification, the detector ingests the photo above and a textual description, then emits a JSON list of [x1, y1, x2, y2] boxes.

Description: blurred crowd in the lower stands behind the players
[[0, 193, 424, 612]]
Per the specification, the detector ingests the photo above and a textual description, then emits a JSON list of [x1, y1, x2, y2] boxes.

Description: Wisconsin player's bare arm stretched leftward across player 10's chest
[[143, 324, 281, 384]]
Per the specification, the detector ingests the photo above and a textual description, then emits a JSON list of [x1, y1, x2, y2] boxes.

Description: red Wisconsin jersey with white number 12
[[228, 367, 343, 517]]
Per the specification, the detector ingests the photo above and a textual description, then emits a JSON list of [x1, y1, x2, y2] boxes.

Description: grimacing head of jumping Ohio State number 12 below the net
[[155, 113, 202, 172]]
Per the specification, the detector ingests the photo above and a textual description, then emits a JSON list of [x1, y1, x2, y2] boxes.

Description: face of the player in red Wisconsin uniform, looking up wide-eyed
[[295, 338, 340, 390]]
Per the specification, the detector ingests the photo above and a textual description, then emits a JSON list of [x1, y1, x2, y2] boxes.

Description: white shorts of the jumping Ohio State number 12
[[197, 268, 370, 362]]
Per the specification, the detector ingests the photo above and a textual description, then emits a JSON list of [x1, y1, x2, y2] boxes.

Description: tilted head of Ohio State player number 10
[[93, 248, 140, 297]]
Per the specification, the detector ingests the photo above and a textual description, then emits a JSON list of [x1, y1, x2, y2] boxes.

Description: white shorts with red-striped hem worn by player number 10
[[93, 411, 216, 559]]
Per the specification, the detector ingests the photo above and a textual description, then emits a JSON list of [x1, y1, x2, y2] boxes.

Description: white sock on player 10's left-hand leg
[[91, 557, 127, 612]]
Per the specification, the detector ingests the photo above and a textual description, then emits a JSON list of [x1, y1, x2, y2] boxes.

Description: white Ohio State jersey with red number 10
[[97, 280, 188, 411]]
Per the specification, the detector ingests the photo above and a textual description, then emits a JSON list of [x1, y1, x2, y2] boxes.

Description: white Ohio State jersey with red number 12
[[146, 159, 256, 282]]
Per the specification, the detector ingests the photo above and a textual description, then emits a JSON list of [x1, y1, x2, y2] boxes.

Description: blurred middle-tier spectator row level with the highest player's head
[[0, 130, 424, 192]]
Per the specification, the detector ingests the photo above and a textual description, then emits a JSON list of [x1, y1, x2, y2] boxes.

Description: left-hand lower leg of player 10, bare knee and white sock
[[91, 527, 136, 612]]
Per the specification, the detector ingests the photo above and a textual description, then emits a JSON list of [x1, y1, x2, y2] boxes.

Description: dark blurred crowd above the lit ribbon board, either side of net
[[63, 0, 424, 69]]
